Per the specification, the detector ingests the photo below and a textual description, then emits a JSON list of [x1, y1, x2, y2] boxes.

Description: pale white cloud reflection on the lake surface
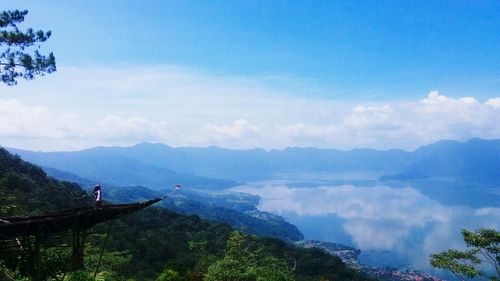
[[236, 185, 451, 227]]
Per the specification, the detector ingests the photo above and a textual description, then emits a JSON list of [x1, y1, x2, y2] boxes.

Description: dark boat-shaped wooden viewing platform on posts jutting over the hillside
[[0, 196, 168, 281]]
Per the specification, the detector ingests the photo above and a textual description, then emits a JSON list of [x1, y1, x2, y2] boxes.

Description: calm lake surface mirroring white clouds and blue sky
[[236, 182, 500, 269]]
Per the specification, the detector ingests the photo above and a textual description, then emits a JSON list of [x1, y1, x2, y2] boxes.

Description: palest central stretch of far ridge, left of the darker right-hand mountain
[[91, 143, 414, 181]]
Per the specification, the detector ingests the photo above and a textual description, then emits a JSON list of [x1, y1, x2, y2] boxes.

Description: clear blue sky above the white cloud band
[[6, 1, 500, 99]]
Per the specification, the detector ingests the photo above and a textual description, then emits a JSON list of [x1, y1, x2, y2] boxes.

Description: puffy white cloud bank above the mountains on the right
[[276, 91, 500, 149]]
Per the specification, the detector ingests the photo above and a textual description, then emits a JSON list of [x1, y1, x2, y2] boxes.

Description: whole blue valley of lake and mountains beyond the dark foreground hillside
[[4, 139, 500, 280]]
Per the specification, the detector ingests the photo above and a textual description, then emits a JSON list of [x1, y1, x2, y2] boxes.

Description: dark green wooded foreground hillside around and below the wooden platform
[[0, 149, 374, 280]]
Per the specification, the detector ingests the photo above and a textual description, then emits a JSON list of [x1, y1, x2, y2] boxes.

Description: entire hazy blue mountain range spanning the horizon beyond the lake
[[10, 139, 500, 183]]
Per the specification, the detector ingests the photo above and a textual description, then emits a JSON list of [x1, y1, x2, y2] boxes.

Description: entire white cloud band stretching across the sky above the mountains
[[0, 67, 500, 150]]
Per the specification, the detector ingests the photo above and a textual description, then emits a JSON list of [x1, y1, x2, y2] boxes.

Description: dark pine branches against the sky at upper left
[[0, 10, 56, 85]]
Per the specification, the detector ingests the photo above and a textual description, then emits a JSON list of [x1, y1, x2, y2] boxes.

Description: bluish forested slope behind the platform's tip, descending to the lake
[[38, 168, 304, 241]]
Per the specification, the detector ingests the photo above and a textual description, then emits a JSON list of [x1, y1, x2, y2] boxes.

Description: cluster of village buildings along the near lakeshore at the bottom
[[297, 240, 444, 281]]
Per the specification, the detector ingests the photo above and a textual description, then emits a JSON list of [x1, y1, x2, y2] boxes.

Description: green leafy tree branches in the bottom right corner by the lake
[[430, 228, 500, 280]]
